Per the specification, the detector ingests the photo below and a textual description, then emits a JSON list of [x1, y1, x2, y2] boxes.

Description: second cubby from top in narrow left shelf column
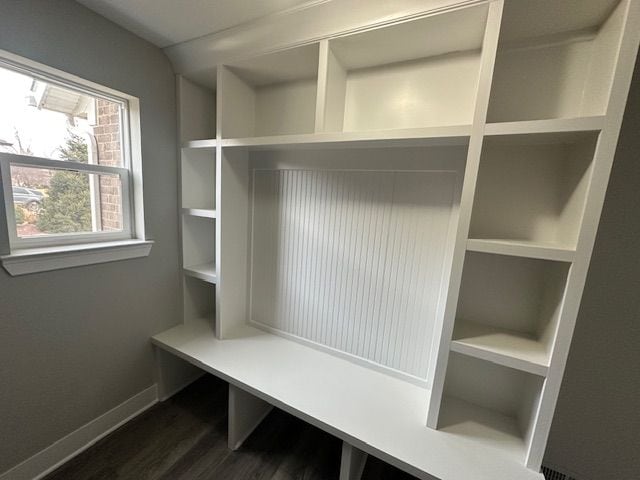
[[181, 148, 216, 210]]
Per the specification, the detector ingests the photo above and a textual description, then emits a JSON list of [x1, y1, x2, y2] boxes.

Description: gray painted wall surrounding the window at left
[[0, 0, 181, 472]]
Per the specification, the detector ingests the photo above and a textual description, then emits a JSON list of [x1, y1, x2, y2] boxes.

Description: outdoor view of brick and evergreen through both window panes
[[0, 62, 129, 244]]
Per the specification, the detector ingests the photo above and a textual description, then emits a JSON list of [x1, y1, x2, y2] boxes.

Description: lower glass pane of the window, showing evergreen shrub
[[11, 165, 123, 238]]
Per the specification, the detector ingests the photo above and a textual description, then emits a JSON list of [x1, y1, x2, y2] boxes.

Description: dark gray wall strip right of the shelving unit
[[545, 53, 640, 480]]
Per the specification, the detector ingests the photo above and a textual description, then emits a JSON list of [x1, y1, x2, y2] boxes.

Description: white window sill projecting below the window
[[0, 239, 153, 277]]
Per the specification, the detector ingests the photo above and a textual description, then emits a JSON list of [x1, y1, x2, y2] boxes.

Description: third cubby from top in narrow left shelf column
[[182, 215, 216, 283]]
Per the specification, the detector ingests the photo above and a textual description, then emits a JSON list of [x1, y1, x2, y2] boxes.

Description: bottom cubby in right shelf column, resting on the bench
[[439, 353, 544, 462]]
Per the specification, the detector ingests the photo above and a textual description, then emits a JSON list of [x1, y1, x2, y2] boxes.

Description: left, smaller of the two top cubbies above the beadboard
[[218, 44, 319, 138]]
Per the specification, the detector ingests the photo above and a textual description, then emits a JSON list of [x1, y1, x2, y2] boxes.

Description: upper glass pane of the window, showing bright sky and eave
[[0, 67, 124, 166]]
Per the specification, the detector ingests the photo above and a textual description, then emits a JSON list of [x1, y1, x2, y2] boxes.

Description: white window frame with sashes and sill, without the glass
[[0, 50, 153, 275]]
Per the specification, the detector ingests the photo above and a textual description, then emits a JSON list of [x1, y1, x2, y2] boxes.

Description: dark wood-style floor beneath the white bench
[[46, 375, 414, 480]]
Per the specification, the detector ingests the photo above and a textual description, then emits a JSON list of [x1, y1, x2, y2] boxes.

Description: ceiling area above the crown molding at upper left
[[77, 0, 317, 48]]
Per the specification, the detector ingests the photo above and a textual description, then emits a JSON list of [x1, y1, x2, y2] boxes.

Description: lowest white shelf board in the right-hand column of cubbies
[[451, 319, 549, 376]]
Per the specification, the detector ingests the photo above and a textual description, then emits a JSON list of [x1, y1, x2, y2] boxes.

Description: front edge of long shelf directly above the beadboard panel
[[220, 125, 471, 148]]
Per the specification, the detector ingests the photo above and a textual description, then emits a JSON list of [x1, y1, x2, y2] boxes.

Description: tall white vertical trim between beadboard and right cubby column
[[427, 0, 503, 428]]
